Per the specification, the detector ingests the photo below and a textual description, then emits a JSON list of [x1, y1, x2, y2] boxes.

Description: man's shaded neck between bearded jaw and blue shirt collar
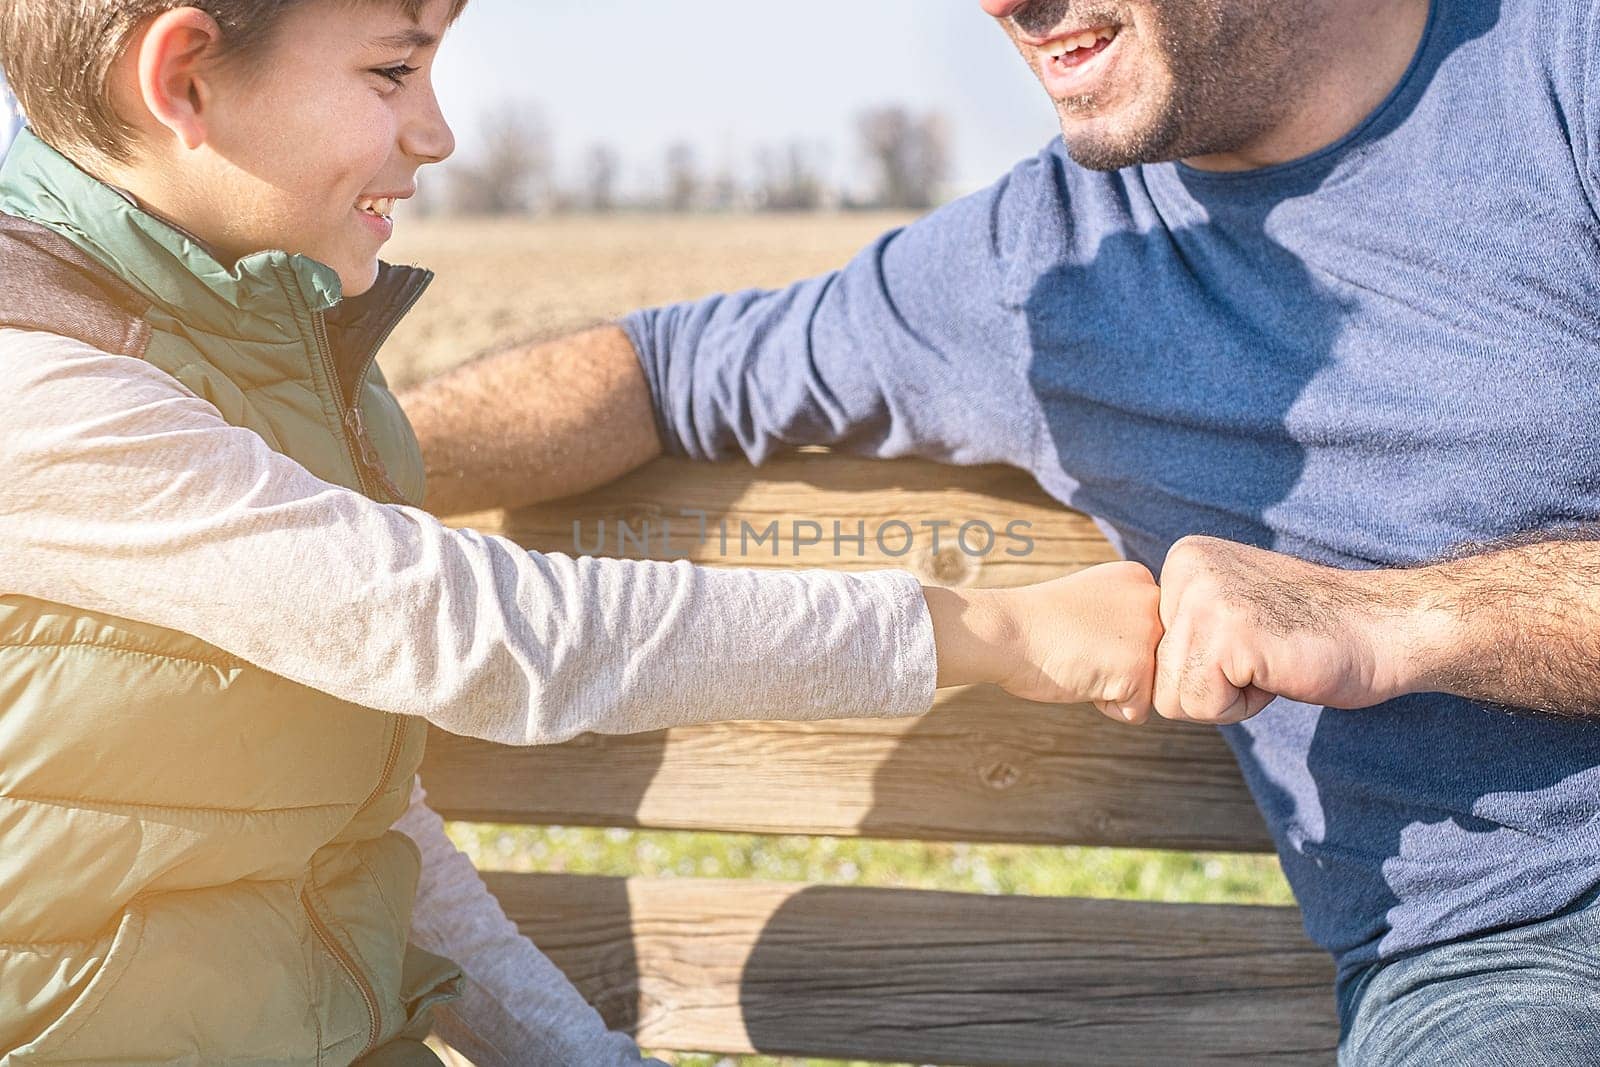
[[1184, 0, 1430, 171]]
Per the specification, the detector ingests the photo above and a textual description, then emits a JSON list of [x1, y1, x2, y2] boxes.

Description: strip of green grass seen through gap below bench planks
[[450, 822, 1294, 1067]]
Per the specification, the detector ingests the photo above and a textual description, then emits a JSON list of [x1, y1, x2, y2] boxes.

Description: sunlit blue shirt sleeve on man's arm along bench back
[[622, 157, 1050, 464]]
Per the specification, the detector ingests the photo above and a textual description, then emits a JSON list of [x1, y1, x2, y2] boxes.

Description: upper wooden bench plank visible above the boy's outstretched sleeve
[[450, 450, 1117, 585]]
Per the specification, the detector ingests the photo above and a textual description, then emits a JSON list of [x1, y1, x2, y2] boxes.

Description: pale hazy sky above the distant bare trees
[[435, 0, 1056, 192]]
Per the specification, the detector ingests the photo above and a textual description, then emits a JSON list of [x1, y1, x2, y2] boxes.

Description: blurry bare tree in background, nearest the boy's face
[[451, 104, 554, 214]]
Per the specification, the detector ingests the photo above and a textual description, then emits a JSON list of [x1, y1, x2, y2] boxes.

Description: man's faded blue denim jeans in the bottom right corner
[[1339, 896, 1600, 1067]]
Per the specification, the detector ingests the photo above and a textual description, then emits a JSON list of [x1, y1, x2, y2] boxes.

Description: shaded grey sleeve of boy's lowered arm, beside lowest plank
[[395, 781, 661, 1067]]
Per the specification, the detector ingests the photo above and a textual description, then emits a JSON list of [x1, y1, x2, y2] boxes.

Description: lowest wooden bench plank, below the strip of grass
[[488, 873, 1338, 1067]]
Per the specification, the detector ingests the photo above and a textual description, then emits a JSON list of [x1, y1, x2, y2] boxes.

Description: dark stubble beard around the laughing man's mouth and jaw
[[1056, 0, 1312, 171]]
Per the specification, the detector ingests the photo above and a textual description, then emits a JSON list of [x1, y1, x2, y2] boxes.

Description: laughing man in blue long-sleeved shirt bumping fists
[[402, 0, 1600, 1064]]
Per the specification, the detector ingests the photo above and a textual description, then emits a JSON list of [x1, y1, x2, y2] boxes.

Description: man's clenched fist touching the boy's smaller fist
[[1155, 537, 1414, 725]]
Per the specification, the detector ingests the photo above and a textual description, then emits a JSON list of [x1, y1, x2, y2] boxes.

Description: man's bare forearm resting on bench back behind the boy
[[400, 326, 662, 515]]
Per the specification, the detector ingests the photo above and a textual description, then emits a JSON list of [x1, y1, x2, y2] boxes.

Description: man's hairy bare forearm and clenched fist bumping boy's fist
[[1155, 526, 1600, 723]]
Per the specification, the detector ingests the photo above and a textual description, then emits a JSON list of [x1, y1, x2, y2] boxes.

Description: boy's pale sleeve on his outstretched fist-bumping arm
[[0, 330, 936, 744]]
